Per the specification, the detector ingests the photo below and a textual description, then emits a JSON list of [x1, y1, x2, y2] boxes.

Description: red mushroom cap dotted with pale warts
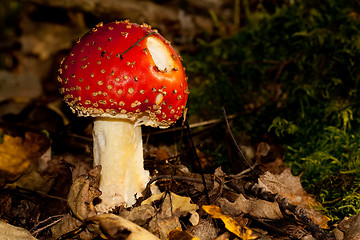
[[58, 21, 189, 127]]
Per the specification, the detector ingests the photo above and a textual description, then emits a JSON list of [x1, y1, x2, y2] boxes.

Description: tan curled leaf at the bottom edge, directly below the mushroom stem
[[84, 213, 159, 240]]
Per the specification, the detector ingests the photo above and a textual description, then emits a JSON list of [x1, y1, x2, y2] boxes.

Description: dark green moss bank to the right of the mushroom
[[184, 0, 360, 219]]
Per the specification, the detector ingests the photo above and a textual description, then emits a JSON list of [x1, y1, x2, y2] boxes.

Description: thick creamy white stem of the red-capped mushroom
[[93, 118, 149, 213]]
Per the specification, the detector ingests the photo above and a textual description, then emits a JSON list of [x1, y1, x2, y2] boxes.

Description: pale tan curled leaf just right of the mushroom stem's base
[[141, 192, 199, 239]]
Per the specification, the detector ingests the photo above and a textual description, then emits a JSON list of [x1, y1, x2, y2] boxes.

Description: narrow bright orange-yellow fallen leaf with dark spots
[[202, 205, 258, 240]]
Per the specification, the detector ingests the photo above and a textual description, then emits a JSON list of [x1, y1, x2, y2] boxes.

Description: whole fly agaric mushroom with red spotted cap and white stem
[[58, 20, 189, 212]]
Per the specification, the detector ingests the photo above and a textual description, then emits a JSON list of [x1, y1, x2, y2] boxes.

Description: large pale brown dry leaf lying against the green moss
[[259, 168, 329, 228]]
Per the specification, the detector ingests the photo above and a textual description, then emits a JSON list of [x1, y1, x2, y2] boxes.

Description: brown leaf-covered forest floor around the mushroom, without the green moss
[[0, 0, 360, 240]]
